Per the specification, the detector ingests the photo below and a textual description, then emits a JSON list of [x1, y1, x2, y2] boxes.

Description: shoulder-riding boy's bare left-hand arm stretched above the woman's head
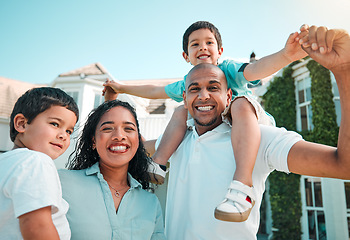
[[103, 80, 169, 100]]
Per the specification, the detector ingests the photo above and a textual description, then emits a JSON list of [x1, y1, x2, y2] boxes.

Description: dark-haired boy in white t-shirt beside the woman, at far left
[[0, 87, 79, 240]]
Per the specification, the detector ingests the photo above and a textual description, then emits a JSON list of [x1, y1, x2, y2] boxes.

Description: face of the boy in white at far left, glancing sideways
[[15, 106, 77, 159]]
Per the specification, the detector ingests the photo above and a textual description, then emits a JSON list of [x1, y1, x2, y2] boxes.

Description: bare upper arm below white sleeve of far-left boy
[[18, 206, 60, 240]]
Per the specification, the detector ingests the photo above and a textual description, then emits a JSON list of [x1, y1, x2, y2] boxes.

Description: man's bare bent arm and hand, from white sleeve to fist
[[288, 26, 350, 179]]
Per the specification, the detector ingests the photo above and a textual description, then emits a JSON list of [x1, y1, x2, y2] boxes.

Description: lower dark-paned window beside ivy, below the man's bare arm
[[303, 177, 326, 240]]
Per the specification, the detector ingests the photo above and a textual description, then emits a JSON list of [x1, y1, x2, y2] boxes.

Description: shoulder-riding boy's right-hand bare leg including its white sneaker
[[215, 97, 260, 222]]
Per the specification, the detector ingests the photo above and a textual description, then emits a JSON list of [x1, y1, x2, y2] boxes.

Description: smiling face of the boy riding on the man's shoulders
[[182, 28, 223, 66]]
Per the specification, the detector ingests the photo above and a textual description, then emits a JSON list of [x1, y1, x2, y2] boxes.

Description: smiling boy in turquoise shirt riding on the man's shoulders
[[104, 21, 307, 222]]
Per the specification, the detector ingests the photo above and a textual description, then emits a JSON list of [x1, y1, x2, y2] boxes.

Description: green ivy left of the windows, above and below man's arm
[[263, 62, 301, 240]]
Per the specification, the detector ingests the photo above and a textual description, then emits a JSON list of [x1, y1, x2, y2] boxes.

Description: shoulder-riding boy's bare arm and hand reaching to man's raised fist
[[244, 29, 307, 81]]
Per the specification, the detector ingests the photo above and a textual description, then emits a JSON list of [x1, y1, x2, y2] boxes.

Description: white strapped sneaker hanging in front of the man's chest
[[214, 180, 255, 222]]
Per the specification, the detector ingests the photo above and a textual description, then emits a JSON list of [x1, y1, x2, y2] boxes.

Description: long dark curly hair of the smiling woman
[[67, 100, 151, 189]]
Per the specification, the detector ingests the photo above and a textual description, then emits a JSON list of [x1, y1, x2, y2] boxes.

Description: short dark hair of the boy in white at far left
[[10, 87, 79, 141]]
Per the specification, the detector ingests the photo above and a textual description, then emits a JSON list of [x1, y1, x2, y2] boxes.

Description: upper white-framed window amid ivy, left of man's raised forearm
[[296, 77, 313, 131]]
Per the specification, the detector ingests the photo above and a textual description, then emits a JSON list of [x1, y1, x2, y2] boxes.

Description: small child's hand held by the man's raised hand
[[283, 32, 307, 62]]
